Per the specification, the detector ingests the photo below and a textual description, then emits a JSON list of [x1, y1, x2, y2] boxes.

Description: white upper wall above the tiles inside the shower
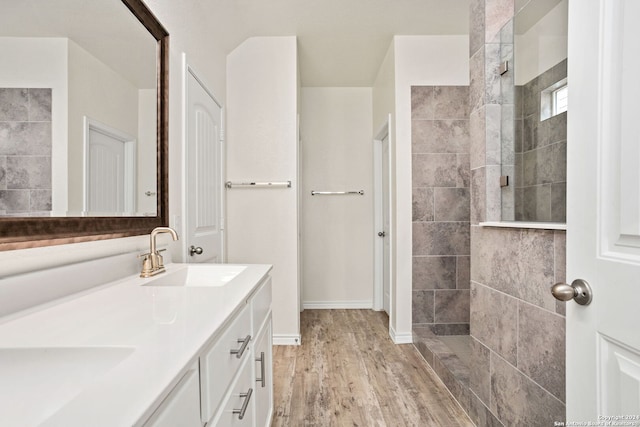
[[514, 0, 569, 86]]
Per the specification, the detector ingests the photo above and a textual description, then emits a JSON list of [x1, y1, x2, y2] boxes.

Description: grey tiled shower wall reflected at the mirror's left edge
[[0, 88, 52, 216]]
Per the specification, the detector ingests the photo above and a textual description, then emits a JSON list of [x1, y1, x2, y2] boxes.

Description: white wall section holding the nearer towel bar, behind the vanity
[[227, 37, 300, 344]]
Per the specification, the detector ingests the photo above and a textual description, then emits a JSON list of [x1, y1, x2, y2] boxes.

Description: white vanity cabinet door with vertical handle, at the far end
[[253, 313, 273, 427]]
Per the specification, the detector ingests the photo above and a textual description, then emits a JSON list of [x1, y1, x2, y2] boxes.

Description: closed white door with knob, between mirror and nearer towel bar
[[185, 68, 224, 262]]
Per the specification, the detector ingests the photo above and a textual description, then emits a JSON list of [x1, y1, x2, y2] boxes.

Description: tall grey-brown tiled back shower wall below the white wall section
[[411, 86, 470, 335]]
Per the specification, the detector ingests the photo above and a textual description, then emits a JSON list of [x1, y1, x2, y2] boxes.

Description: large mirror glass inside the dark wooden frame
[[0, 0, 159, 218]]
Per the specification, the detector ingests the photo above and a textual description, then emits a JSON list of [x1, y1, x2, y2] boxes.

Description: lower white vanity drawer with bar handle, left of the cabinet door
[[207, 360, 256, 427]]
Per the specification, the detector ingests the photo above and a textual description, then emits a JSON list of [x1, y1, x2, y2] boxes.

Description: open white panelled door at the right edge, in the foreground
[[567, 0, 640, 425]]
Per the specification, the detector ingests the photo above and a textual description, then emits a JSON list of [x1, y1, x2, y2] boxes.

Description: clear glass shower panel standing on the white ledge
[[500, 0, 569, 223]]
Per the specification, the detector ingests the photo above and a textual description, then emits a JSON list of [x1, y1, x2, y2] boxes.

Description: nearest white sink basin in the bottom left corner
[[0, 347, 134, 425]]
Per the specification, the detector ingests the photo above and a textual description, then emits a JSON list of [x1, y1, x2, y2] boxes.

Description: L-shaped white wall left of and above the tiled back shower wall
[[390, 35, 469, 342]]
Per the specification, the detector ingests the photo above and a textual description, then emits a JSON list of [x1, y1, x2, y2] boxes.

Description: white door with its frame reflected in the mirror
[[84, 117, 136, 215]]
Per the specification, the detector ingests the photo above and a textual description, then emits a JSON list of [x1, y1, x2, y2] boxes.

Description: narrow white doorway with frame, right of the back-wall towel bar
[[373, 114, 394, 318]]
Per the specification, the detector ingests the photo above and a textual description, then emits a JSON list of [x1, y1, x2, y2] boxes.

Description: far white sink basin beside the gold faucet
[[144, 264, 247, 287]]
